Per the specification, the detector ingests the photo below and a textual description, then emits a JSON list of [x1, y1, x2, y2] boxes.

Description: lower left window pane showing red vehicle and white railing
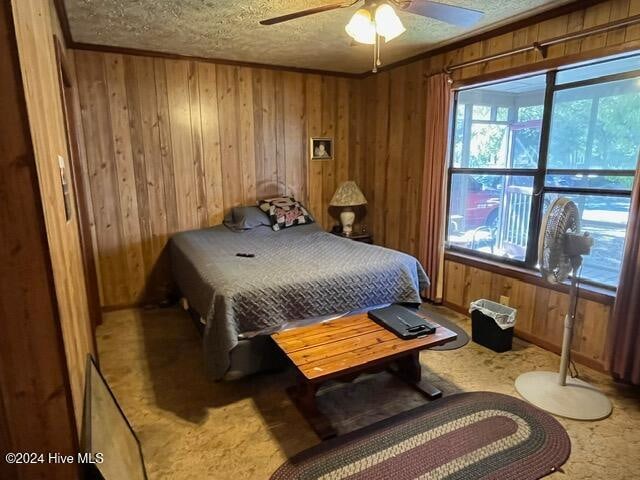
[[447, 174, 533, 260]]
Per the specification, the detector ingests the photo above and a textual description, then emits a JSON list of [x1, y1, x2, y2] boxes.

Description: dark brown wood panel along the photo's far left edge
[[0, 2, 78, 480]]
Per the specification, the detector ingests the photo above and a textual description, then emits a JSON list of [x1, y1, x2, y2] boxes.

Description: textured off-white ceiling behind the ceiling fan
[[65, 0, 568, 73]]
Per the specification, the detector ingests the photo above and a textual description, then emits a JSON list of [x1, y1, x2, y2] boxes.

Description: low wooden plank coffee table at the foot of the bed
[[271, 313, 457, 440]]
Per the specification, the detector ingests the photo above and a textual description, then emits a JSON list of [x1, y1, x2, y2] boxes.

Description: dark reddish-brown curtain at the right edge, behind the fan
[[608, 171, 640, 385]]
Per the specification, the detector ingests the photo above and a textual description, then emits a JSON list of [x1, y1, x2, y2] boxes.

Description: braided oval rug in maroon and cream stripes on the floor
[[271, 392, 571, 480]]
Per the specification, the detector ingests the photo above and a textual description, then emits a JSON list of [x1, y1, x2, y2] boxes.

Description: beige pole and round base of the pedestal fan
[[516, 257, 611, 420]]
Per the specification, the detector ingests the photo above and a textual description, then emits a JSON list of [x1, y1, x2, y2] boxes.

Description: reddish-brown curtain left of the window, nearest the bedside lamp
[[418, 73, 451, 302]]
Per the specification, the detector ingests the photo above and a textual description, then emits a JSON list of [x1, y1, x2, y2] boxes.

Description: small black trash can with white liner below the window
[[469, 299, 517, 352]]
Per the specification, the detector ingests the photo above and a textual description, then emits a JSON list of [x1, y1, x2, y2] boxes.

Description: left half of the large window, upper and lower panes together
[[447, 75, 545, 262]]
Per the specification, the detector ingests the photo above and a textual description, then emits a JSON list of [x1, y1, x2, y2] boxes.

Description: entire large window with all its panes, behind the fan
[[447, 55, 640, 287]]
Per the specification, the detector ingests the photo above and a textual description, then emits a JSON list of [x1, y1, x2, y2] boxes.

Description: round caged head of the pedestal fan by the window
[[538, 197, 588, 283]]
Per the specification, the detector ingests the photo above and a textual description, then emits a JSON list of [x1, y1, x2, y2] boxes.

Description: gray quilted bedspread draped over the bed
[[170, 224, 429, 379]]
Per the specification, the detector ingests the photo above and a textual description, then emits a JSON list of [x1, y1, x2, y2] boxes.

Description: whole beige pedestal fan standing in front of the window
[[516, 198, 611, 420]]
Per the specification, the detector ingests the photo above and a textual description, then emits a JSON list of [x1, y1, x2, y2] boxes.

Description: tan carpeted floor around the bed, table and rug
[[98, 309, 640, 480]]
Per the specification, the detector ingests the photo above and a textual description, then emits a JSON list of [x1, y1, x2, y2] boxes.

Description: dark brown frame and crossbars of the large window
[[445, 53, 640, 292]]
